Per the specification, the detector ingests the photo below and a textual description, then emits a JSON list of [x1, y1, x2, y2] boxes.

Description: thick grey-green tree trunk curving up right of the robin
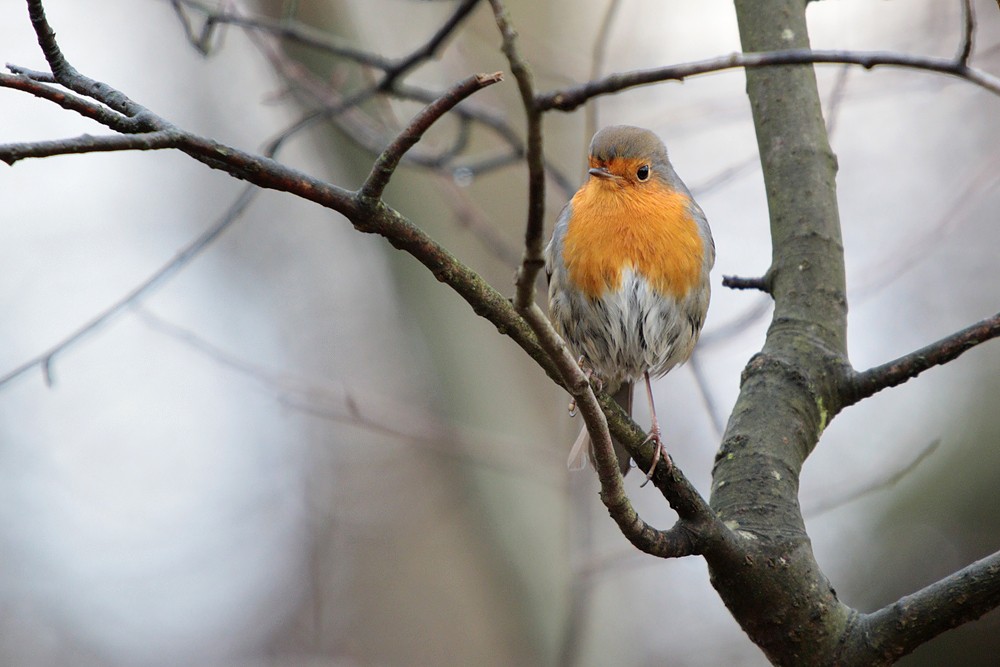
[[706, 0, 853, 665]]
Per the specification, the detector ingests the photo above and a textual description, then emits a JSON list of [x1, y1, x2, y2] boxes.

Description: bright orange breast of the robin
[[563, 178, 704, 299]]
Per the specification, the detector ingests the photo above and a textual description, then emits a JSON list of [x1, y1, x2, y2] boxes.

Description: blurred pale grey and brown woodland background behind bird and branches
[[0, 0, 1000, 667]]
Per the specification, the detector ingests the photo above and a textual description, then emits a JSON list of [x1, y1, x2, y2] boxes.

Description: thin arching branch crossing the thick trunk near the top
[[535, 49, 1000, 111]]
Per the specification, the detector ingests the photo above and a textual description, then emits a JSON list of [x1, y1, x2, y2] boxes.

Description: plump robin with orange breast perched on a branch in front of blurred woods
[[545, 125, 715, 481]]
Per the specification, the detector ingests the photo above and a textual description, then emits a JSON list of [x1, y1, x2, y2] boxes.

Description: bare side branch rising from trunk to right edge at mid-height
[[843, 313, 1000, 407]]
